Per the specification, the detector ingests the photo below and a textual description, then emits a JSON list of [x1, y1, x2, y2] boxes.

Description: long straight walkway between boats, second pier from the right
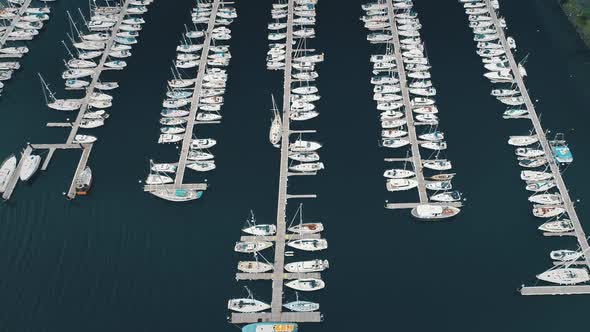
[[387, 0, 428, 204]]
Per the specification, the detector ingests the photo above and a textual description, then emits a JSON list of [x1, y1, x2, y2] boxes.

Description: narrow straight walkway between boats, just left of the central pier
[[174, 0, 222, 188]]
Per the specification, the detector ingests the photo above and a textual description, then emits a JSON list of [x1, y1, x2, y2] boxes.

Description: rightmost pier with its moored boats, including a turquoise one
[[459, 0, 590, 295]]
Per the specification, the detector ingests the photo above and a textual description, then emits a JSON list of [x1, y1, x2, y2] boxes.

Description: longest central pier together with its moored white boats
[[228, 0, 328, 327]]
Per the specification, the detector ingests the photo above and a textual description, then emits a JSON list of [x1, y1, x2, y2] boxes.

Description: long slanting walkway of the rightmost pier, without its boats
[[485, 0, 590, 272]]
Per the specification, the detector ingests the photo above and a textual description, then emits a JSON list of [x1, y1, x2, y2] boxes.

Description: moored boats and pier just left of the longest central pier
[[145, 0, 237, 202]]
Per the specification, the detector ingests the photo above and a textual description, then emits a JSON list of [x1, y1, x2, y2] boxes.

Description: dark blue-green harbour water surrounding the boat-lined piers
[[0, 0, 590, 332]]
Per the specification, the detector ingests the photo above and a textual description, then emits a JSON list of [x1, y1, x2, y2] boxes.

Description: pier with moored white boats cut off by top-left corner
[[0, 0, 51, 93]]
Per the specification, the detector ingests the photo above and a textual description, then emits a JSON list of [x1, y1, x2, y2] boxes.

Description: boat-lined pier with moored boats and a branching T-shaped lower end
[[4, 0, 153, 199]]
